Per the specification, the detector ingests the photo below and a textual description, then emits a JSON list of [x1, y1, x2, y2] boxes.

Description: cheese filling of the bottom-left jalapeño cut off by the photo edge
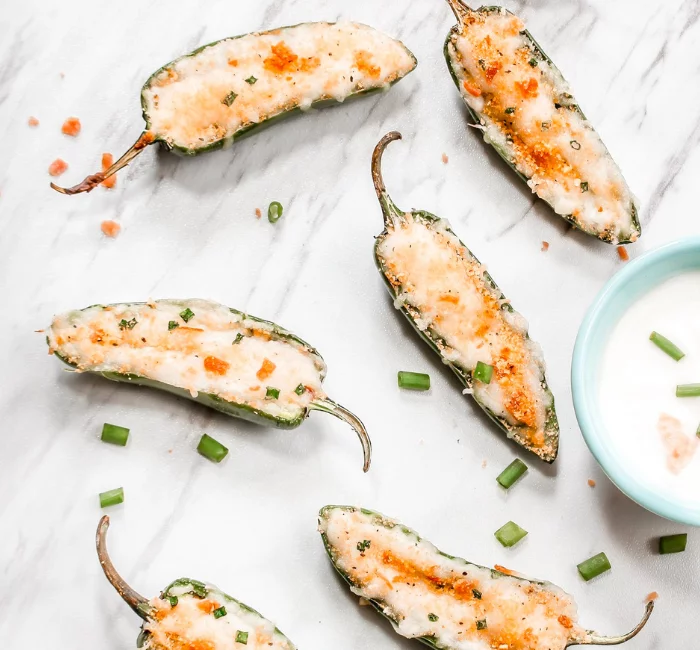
[[144, 586, 294, 650]]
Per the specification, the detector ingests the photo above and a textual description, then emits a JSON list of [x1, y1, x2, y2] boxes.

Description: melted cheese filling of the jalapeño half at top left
[[143, 23, 416, 149]]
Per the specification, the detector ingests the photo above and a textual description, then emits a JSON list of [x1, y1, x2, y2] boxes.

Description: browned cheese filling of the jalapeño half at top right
[[448, 11, 639, 242]]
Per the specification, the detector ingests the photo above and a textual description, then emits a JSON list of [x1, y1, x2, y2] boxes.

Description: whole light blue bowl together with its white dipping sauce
[[571, 237, 700, 526]]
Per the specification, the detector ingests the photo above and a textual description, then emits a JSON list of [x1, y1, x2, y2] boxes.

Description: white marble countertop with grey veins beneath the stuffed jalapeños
[[0, 0, 700, 650]]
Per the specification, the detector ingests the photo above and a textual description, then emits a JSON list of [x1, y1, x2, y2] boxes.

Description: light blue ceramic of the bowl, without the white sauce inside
[[571, 237, 700, 526]]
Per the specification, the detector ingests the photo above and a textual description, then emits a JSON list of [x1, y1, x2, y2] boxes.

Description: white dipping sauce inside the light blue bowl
[[598, 271, 700, 506]]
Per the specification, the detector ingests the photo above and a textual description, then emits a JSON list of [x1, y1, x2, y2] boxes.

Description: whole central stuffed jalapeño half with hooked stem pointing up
[[372, 131, 559, 463]]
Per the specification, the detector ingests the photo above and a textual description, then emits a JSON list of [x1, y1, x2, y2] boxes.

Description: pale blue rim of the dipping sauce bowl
[[571, 236, 700, 526]]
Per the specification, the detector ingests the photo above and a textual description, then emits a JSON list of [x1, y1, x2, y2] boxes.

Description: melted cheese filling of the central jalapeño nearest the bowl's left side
[[377, 213, 551, 447]]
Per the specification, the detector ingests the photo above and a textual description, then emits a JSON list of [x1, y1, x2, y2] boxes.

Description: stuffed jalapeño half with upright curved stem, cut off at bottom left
[[96, 515, 296, 650]]
